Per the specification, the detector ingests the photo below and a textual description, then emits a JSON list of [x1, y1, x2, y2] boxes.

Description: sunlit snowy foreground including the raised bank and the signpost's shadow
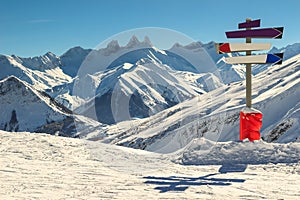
[[0, 131, 300, 199]]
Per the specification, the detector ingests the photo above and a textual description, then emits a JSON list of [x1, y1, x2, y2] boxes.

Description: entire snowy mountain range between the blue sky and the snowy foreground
[[0, 36, 300, 145]]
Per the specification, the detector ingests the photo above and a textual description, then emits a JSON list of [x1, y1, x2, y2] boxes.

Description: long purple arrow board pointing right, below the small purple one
[[226, 27, 283, 39]]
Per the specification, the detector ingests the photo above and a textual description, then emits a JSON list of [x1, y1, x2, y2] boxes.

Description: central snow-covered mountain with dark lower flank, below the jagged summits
[[75, 59, 206, 124]]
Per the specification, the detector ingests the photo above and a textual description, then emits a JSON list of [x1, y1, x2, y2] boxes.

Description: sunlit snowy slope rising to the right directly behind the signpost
[[92, 55, 300, 152]]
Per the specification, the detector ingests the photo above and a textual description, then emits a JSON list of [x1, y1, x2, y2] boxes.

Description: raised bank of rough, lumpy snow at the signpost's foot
[[175, 138, 300, 165]]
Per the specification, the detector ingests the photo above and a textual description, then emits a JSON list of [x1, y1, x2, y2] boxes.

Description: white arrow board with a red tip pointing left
[[216, 43, 271, 54]]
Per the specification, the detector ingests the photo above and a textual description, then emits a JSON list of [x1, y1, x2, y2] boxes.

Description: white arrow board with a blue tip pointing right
[[225, 53, 283, 64]]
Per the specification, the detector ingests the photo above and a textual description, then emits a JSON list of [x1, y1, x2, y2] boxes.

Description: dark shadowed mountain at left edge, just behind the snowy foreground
[[0, 76, 101, 137]]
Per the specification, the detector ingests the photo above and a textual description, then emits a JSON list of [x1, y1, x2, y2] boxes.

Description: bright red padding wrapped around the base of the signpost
[[240, 111, 263, 142]]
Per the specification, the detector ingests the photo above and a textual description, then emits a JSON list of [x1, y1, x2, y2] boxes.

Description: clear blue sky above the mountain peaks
[[0, 0, 300, 57]]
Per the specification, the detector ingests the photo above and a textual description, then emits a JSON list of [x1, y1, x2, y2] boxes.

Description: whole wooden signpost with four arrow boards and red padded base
[[216, 18, 283, 141]]
